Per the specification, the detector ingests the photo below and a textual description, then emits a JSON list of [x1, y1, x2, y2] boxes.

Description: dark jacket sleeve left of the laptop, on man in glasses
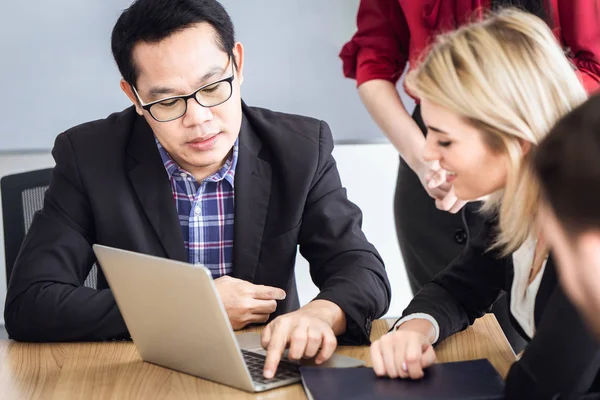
[[4, 134, 128, 342]]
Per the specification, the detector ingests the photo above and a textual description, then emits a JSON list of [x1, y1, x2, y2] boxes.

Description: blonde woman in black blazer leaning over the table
[[371, 10, 600, 399]]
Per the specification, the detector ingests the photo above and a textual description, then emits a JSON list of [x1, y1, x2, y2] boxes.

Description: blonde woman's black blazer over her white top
[[403, 213, 600, 399]]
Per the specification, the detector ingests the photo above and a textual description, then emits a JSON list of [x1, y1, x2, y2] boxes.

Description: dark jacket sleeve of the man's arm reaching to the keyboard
[[299, 122, 391, 344]]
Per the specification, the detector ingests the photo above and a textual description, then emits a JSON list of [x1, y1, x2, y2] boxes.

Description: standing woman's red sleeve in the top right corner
[[557, 0, 600, 93]]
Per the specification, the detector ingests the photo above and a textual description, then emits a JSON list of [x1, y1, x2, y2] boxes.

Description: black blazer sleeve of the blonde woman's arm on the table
[[402, 213, 510, 342]]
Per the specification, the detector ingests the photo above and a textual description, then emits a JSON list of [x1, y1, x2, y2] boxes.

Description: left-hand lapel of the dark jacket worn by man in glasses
[[127, 117, 188, 262]]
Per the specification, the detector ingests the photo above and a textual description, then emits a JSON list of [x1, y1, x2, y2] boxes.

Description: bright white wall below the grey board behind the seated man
[[0, 144, 412, 323]]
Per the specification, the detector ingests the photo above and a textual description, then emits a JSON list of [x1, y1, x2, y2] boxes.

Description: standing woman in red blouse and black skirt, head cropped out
[[340, 0, 600, 350]]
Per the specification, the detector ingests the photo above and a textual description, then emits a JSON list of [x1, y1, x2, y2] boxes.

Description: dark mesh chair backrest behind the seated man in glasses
[[0, 168, 97, 288]]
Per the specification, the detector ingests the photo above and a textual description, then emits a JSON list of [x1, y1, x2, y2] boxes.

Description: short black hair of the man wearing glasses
[[111, 0, 237, 85]]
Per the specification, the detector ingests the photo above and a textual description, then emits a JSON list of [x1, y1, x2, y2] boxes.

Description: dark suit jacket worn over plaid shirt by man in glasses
[[4, 104, 390, 344]]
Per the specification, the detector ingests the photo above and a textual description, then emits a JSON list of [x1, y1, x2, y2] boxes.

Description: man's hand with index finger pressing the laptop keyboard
[[262, 300, 346, 379]]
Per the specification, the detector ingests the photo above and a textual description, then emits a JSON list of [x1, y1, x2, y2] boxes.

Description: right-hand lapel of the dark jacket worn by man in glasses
[[233, 110, 271, 282]]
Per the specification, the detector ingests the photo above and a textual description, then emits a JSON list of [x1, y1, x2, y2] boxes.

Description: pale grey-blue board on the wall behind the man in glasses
[[0, 0, 408, 151]]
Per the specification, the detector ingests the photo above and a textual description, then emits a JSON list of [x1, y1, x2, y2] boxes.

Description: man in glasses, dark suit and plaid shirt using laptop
[[5, 0, 390, 377]]
